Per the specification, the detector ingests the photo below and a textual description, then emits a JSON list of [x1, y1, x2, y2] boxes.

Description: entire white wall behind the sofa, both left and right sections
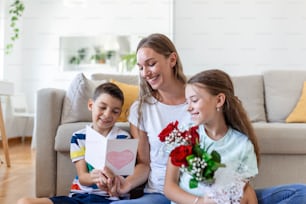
[[0, 0, 306, 137]]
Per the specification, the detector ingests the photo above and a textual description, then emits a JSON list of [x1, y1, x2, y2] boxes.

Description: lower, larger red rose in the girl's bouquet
[[170, 145, 192, 167]]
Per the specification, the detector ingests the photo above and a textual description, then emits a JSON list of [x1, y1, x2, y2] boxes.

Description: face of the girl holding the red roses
[[185, 84, 218, 125]]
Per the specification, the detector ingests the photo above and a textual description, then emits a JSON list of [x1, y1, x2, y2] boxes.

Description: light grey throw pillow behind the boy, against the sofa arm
[[61, 73, 106, 124]]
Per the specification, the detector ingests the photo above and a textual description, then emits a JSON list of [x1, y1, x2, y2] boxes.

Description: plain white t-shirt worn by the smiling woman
[[128, 97, 191, 193]]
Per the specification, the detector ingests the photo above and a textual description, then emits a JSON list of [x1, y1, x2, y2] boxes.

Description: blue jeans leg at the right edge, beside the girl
[[255, 184, 306, 204]]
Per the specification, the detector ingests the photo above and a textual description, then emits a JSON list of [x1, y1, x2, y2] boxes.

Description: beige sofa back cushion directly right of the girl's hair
[[231, 75, 266, 122]]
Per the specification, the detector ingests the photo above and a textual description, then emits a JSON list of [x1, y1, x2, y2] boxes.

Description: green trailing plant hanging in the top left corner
[[5, 0, 25, 54]]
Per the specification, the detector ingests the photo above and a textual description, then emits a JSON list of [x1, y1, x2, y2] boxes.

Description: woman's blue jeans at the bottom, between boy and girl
[[111, 193, 171, 204]]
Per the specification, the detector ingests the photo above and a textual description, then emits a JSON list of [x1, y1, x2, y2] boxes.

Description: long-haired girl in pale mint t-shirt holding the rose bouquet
[[165, 70, 259, 204]]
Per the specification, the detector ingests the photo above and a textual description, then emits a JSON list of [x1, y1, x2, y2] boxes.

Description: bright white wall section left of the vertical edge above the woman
[[0, 0, 173, 139]]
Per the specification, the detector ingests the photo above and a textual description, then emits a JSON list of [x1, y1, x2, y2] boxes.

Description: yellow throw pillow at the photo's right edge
[[286, 82, 306, 123]]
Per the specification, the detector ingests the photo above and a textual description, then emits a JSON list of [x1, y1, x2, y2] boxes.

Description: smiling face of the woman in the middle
[[137, 47, 176, 90]]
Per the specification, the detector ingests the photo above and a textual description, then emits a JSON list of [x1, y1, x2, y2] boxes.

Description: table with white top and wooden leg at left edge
[[0, 81, 14, 167]]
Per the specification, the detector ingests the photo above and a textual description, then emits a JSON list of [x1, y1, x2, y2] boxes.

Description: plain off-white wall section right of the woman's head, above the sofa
[[174, 0, 306, 75]]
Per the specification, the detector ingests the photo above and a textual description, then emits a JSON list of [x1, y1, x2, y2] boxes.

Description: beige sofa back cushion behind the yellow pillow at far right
[[263, 70, 306, 122]]
